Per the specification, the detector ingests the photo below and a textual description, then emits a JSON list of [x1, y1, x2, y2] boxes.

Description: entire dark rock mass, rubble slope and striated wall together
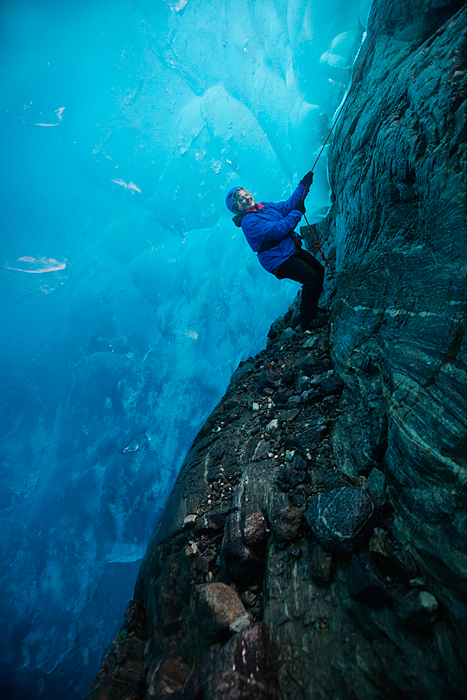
[[88, 0, 467, 700]]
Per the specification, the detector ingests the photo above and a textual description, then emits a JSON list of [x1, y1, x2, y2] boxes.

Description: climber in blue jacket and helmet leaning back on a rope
[[226, 171, 328, 330]]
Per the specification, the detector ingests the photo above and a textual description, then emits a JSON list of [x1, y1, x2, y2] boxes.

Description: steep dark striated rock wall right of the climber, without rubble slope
[[327, 0, 467, 636]]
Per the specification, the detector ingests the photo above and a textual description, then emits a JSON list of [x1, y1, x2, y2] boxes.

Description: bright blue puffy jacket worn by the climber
[[233, 183, 305, 272]]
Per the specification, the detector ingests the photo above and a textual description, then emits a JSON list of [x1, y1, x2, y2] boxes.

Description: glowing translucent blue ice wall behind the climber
[[0, 0, 368, 700]]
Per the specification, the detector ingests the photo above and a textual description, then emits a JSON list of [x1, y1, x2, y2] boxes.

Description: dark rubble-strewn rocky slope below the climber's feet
[[89, 308, 465, 700]]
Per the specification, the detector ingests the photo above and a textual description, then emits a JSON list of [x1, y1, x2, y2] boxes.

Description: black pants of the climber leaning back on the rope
[[273, 248, 324, 327]]
